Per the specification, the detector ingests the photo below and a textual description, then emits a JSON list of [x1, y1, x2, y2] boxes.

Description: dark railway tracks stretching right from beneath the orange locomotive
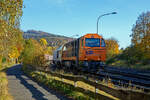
[[50, 66, 150, 92]]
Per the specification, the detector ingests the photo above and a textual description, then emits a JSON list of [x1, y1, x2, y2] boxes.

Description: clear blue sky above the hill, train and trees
[[21, 0, 150, 48]]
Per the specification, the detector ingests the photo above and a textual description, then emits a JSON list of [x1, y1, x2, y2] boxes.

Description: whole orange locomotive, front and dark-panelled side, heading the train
[[59, 34, 106, 70]]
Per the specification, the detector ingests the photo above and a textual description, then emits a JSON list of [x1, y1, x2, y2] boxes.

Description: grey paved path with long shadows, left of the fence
[[7, 65, 69, 100]]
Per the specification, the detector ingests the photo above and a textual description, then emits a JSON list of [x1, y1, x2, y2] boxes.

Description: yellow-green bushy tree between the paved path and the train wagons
[[21, 39, 50, 68]]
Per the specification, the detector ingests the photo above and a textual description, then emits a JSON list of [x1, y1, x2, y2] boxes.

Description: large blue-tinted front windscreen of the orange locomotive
[[85, 38, 100, 47]]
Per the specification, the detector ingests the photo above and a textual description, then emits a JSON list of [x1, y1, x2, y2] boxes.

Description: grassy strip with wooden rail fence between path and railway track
[[23, 64, 150, 100]]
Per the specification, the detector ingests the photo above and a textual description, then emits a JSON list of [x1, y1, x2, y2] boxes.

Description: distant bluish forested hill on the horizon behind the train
[[23, 30, 72, 46]]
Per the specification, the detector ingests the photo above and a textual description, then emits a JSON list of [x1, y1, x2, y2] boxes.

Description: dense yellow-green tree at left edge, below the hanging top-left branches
[[0, 21, 23, 63]]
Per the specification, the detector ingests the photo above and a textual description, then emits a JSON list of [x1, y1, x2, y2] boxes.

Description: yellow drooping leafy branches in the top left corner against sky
[[0, 0, 23, 28]]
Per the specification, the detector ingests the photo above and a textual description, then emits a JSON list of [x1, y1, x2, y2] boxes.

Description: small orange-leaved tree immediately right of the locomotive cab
[[105, 38, 119, 59]]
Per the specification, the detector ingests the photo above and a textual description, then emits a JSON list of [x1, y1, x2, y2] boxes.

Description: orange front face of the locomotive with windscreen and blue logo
[[79, 34, 106, 62]]
